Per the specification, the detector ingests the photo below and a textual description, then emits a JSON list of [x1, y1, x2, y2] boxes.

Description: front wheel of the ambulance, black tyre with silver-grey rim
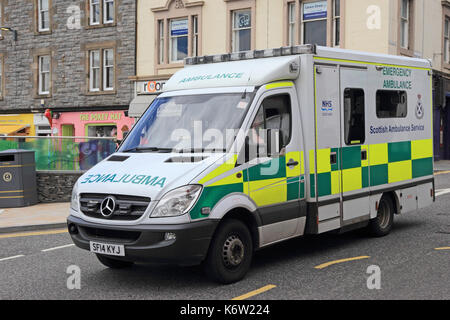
[[203, 219, 253, 284]]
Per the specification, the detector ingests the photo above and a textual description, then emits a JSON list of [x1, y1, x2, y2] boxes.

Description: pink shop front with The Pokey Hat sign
[[52, 111, 135, 140]]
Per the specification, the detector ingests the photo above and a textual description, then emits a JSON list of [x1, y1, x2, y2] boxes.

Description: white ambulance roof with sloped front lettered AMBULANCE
[[164, 45, 431, 92]]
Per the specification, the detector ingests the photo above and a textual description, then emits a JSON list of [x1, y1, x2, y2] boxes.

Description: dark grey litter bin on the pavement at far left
[[0, 150, 38, 208]]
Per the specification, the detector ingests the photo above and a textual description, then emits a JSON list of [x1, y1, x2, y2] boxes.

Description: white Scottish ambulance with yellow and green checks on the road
[[68, 45, 435, 283]]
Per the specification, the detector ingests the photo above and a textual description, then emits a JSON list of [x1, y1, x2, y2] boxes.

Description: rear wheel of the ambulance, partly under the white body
[[369, 195, 394, 237]]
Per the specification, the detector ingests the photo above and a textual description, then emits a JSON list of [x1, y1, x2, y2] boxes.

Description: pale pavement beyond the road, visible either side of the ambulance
[[0, 160, 450, 233]]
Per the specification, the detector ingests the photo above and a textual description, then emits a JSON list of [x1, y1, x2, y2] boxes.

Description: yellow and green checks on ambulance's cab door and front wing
[[190, 152, 305, 220]]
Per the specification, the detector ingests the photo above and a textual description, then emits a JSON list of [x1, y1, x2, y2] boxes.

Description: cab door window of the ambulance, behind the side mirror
[[250, 94, 292, 156]]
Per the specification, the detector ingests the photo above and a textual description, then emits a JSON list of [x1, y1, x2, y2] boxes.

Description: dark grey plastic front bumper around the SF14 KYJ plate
[[67, 216, 218, 265]]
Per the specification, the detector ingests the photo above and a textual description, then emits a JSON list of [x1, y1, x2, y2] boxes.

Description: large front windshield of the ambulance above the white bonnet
[[119, 93, 254, 152]]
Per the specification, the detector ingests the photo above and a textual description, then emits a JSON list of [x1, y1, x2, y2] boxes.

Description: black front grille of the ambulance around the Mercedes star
[[80, 193, 150, 221]]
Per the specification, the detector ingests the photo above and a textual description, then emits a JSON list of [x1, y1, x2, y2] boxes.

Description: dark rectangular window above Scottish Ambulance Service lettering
[[377, 90, 408, 118]]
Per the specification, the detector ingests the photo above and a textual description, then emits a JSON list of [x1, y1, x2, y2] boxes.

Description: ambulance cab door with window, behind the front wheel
[[244, 83, 306, 245]]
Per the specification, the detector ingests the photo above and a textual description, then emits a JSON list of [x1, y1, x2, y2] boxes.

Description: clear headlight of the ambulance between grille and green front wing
[[151, 185, 202, 218]]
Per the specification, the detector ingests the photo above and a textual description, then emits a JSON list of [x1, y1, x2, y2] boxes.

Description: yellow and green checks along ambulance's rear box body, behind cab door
[[310, 139, 433, 197]]
